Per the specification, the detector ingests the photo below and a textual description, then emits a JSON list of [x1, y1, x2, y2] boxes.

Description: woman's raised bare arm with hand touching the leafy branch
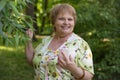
[[25, 30, 34, 64]]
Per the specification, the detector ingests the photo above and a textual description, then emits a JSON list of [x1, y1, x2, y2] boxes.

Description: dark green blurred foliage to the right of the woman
[[71, 0, 120, 80]]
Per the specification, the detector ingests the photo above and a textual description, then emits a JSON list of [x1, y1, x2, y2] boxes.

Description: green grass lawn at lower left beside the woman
[[0, 38, 42, 80]]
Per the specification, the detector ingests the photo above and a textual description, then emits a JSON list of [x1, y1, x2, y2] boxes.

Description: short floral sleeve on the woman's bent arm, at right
[[75, 40, 94, 74]]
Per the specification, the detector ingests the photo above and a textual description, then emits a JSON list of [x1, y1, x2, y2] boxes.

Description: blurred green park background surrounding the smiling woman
[[0, 0, 120, 80]]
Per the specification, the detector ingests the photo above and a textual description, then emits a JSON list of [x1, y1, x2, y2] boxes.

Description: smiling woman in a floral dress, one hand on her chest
[[26, 4, 94, 80]]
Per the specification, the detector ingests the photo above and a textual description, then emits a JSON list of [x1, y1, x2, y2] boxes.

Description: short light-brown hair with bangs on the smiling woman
[[50, 3, 76, 25]]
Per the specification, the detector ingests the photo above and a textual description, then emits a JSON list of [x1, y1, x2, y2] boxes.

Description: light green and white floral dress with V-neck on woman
[[33, 33, 94, 80]]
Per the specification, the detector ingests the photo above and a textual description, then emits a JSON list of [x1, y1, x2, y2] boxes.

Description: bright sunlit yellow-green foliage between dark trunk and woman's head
[[36, 0, 61, 35]]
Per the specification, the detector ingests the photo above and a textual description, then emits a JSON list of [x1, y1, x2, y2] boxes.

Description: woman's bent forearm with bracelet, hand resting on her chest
[[58, 52, 93, 80]]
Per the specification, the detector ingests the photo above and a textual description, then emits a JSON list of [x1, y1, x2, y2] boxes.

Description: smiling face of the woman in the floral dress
[[54, 12, 75, 35]]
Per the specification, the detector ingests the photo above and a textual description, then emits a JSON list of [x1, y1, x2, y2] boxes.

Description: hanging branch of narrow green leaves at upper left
[[0, 0, 33, 46]]
